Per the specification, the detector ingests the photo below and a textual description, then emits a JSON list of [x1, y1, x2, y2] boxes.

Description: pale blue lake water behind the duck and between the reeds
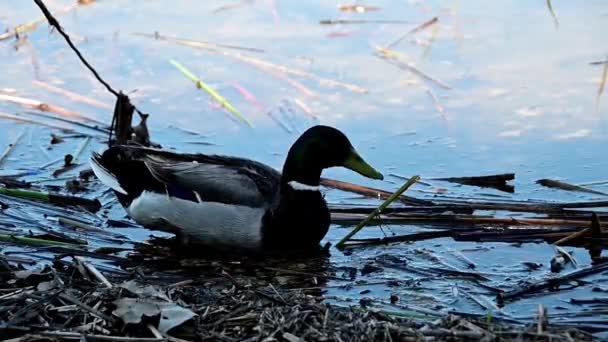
[[0, 0, 608, 336]]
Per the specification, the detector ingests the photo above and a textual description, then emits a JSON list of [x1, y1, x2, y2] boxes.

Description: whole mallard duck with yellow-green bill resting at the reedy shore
[[91, 126, 383, 252]]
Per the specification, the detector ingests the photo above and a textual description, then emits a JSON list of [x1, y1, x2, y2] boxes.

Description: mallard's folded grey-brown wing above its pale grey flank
[[144, 156, 281, 207]]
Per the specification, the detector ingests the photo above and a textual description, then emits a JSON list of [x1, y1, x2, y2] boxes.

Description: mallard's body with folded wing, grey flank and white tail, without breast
[[91, 146, 292, 250]]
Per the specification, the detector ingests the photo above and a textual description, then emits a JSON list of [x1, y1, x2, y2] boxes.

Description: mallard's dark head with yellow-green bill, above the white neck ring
[[283, 125, 384, 184]]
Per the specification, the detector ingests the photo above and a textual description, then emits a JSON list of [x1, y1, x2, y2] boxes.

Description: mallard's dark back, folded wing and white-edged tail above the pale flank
[[91, 145, 281, 208]]
